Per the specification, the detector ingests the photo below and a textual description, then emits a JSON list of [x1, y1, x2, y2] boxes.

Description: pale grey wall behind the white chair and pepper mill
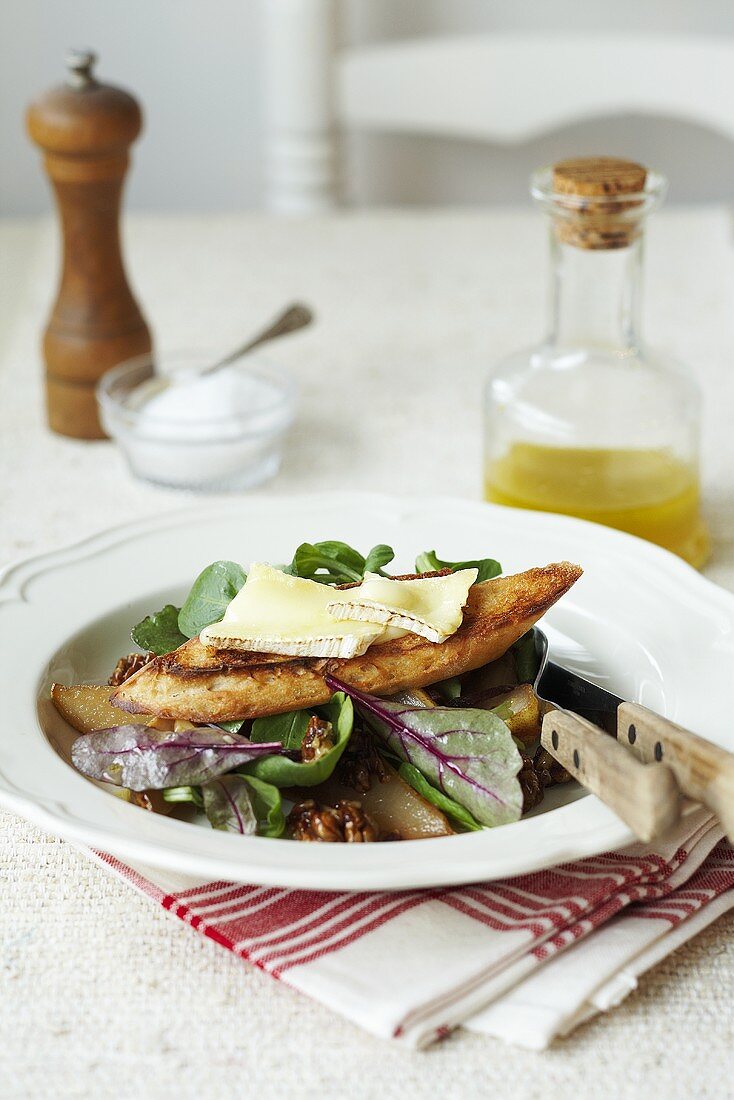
[[0, 0, 734, 215]]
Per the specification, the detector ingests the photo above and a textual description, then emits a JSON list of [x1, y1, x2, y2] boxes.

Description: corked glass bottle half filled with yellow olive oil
[[484, 157, 709, 567]]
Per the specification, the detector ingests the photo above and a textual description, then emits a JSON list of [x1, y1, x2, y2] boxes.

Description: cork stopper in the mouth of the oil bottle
[[551, 156, 647, 250]]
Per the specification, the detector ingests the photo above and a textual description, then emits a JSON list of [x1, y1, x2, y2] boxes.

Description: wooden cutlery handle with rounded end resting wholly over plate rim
[[540, 711, 680, 842]]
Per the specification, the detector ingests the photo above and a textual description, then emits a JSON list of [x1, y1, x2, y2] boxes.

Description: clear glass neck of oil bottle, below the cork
[[549, 227, 643, 352]]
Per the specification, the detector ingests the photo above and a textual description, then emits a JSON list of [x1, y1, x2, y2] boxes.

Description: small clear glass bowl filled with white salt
[[97, 351, 297, 493]]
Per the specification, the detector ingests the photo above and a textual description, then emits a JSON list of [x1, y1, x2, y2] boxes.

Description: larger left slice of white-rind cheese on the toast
[[199, 562, 383, 657]]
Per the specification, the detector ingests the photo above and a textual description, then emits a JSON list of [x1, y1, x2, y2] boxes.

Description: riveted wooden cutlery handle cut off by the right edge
[[617, 703, 734, 843]]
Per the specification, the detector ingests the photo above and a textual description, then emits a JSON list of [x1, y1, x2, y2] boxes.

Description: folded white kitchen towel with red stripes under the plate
[[84, 810, 734, 1048]]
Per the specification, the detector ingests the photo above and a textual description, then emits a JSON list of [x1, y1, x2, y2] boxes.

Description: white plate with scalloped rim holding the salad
[[0, 494, 734, 890]]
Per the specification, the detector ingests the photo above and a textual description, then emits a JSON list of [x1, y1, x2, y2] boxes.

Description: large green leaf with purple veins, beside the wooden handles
[[327, 675, 523, 825]]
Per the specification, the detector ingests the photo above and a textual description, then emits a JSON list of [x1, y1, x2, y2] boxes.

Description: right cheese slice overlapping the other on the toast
[[328, 569, 479, 642]]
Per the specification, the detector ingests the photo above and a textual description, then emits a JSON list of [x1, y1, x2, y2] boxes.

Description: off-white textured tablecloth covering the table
[[0, 208, 734, 1100]]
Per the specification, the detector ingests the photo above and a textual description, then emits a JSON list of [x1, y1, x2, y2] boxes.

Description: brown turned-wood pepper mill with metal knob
[[28, 51, 151, 439]]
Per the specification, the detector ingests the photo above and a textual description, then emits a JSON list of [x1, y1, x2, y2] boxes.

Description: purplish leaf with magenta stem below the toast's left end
[[72, 724, 283, 791]]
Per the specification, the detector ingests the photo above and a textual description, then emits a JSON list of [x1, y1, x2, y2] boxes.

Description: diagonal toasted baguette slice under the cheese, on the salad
[[111, 562, 581, 722]]
